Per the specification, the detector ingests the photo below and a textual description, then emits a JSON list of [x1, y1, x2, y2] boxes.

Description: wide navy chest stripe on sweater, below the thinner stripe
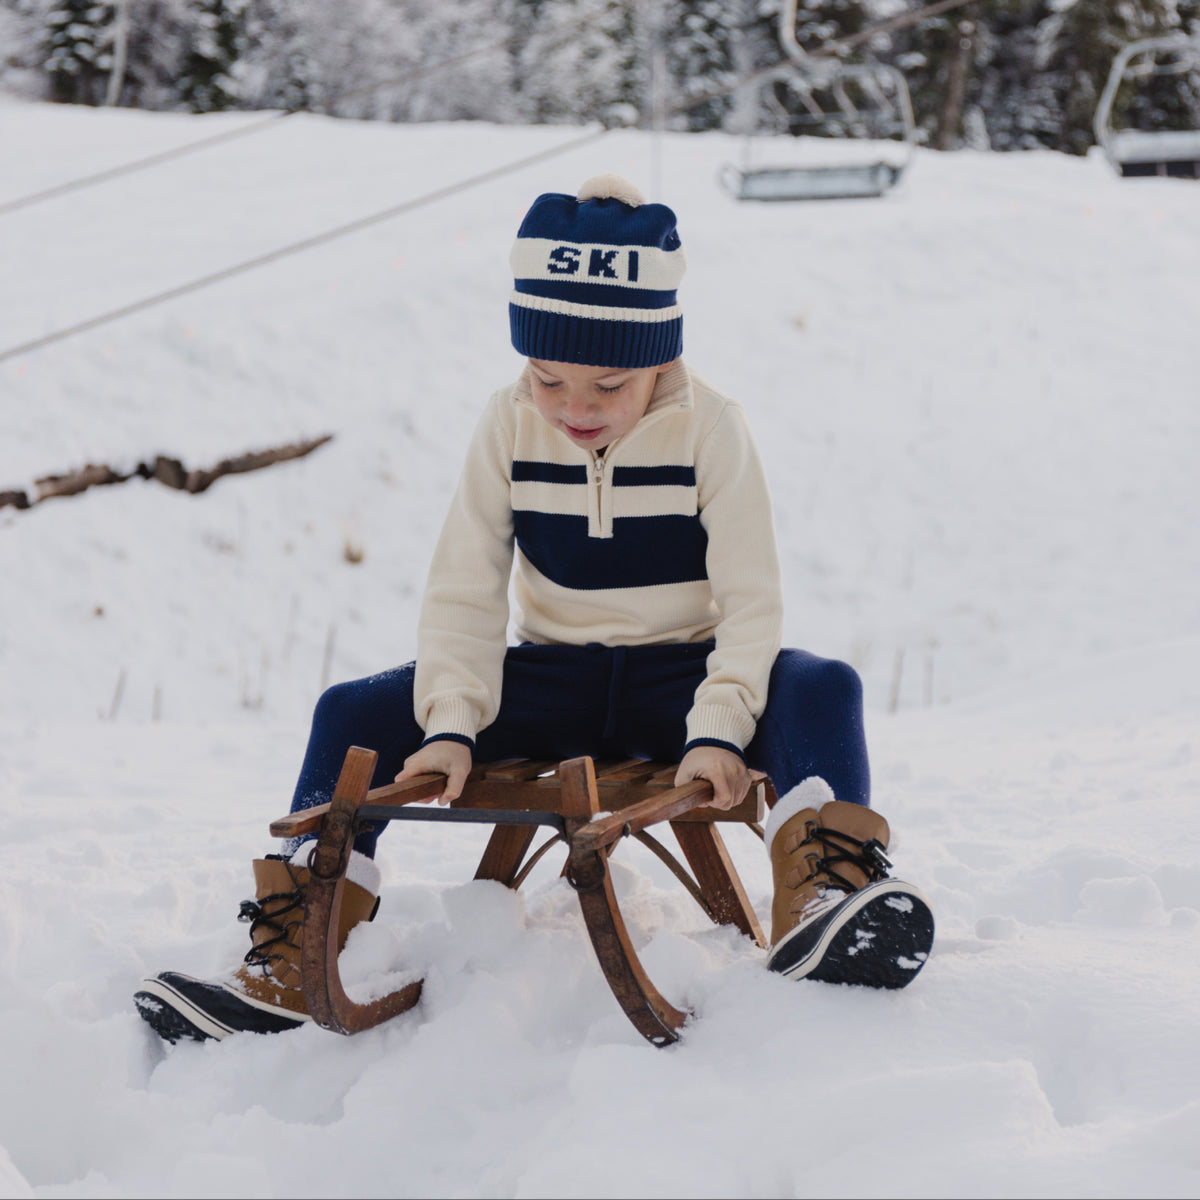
[[512, 511, 708, 592]]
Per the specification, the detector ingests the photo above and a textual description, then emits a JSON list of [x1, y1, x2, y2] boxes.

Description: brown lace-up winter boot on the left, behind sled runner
[[133, 854, 379, 1042]]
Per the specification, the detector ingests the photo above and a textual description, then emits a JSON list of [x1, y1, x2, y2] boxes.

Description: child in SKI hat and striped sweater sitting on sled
[[136, 175, 932, 1040]]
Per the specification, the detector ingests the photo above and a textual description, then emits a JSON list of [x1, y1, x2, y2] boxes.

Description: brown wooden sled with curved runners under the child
[[270, 746, 775, 1046]]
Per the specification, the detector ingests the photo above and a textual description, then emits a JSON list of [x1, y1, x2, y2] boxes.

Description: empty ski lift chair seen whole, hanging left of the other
[[719, 0, 917, 200]]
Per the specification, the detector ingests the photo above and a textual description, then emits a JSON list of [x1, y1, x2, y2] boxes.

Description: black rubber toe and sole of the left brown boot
[[133, 971, 311, 1042]]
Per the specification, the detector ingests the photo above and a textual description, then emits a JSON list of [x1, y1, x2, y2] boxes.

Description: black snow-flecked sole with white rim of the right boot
[[767, 880, 934, 988]]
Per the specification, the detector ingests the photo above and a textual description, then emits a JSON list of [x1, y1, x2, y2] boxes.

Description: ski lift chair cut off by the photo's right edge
[[1093, 34, 1200, 179]]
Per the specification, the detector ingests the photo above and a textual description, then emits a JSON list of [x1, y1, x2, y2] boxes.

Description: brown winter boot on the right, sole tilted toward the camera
[[766, 778, 934, 988]]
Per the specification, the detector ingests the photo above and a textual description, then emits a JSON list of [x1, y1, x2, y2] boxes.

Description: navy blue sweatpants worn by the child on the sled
[[292, 642, 871, 857]]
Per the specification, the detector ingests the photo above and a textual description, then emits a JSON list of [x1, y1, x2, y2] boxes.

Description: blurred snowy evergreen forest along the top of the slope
[[0, 0, 1200, 154]]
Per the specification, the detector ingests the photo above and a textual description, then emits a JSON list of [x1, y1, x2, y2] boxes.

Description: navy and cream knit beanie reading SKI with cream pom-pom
[[509, 174, 686, 368]]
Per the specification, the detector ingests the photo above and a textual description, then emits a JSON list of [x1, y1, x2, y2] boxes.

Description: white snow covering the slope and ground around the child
[[0, 101, 1200, 1198]]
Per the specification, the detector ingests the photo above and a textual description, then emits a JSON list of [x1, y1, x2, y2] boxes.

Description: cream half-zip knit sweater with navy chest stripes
[[414, 361, 782, 750]]
